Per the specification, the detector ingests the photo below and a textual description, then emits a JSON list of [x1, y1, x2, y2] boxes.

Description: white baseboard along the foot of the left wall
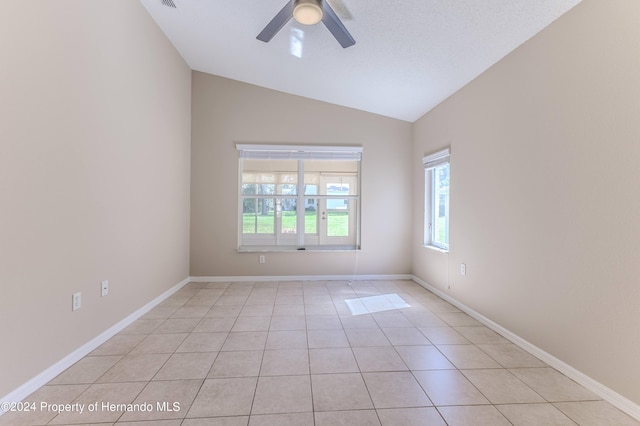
[[0, 278, 190, 416]]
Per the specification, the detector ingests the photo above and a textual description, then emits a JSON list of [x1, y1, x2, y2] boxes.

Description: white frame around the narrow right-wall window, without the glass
[[422, 148, 451, 252]]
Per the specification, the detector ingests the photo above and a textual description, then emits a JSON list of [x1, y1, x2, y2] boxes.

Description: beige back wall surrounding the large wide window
[[191, 72, 411, 276]]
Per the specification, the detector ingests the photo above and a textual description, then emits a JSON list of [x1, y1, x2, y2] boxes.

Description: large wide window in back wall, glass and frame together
[[236, 144, 362, 250]]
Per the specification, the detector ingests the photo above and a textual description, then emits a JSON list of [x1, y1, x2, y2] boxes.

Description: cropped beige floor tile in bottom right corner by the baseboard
[[553, 401, 640, 426]]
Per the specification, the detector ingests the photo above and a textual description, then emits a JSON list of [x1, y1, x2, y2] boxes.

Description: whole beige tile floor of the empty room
[[0, 281, 640, 426]]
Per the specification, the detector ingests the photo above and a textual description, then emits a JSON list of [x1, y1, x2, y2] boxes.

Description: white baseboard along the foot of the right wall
[[412, 276, 640, 420]]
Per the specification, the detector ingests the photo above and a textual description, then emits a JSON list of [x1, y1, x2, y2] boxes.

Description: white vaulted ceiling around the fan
[[140, 0, 581, 122]]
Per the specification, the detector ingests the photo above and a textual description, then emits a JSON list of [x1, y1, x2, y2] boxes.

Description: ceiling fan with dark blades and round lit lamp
[[256, 0, 356, 48]]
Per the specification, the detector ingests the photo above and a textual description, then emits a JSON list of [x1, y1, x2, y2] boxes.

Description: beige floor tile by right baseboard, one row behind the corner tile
[[509, 367, 601, 402]]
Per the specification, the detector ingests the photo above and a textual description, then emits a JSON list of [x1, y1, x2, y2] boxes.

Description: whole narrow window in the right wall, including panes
[[422, 148, 450, 250]]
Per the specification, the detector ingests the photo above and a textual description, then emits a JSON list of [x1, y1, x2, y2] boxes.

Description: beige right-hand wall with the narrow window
[[412, 0, 640, 403]]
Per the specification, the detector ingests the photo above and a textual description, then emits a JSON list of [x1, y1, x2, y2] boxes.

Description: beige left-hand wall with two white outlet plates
[[0, 0, 191, 396]]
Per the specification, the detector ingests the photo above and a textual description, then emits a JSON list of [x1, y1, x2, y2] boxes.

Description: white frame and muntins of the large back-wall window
[[236, 144, 362, 252]]
